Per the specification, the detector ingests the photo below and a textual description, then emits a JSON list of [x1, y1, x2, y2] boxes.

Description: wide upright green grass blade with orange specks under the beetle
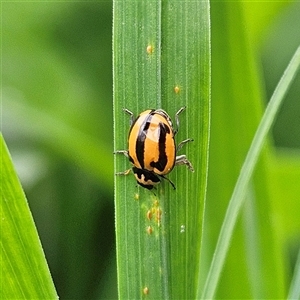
[[113, 1, 210, 299]]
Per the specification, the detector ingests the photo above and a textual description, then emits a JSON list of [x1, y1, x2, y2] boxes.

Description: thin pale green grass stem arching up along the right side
[[202, 48, 300, 299]]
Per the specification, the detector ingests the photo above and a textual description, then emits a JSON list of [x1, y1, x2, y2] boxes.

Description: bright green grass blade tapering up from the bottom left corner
[[0, 135, 58, 299]]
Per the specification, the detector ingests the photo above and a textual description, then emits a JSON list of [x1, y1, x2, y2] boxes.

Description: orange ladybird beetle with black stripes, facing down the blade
[[115, 106, 194, 190]]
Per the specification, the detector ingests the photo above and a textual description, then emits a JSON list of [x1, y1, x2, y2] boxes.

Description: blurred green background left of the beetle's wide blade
[[2, 2, 117, 299]]
